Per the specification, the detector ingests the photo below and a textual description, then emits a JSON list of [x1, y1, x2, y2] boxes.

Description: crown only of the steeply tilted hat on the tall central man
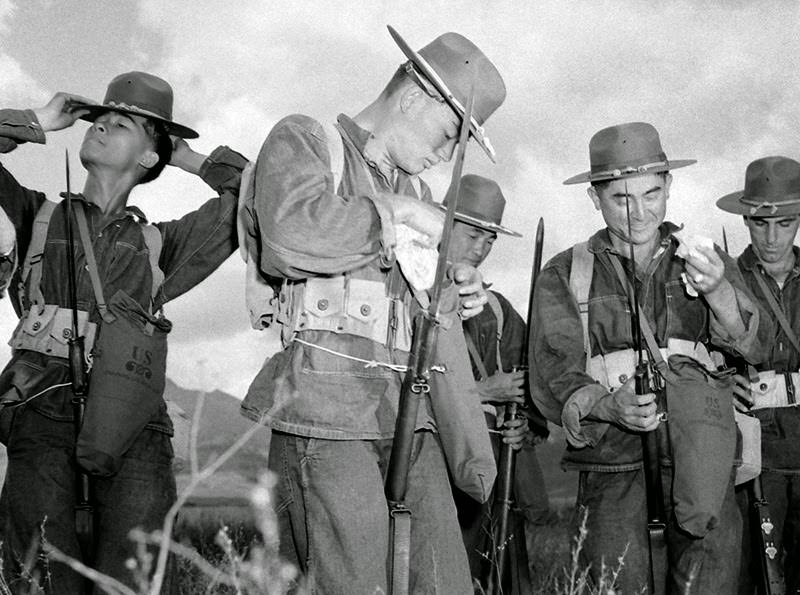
[[418, 32, 506, 125]]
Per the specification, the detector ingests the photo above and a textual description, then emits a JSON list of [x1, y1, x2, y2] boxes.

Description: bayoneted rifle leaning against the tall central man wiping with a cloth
[[384, 74, 475, 595]]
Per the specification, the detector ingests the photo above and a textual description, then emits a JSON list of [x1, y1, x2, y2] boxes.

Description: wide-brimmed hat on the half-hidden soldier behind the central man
[[439, 174, 522, 238]]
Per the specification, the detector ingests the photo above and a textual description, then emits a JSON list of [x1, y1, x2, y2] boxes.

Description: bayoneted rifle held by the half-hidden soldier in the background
[[486, 217, 544, 595]]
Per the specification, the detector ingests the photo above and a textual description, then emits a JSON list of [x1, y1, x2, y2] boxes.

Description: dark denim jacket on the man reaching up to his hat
[[0, 110, 247, 434]]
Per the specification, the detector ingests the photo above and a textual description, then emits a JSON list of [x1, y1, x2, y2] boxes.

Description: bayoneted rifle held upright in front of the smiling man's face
[[625, 191, 667, 595]]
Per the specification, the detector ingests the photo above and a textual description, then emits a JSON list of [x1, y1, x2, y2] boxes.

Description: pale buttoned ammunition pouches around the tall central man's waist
[[277, 275, 411, 351]]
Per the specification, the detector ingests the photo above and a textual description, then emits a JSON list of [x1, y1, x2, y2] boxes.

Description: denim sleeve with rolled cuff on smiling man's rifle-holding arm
[[528, 251, 608, 448]]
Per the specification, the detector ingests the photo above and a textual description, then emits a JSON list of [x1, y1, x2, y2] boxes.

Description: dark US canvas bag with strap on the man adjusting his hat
[[75, 203, 172, 477]]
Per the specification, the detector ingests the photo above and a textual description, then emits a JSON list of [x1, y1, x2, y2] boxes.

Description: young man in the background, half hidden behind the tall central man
[[443, 174, 549, 593]]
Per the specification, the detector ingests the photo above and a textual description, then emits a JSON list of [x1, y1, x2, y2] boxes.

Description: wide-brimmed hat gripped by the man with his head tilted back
[[76, 72, 199, 138]]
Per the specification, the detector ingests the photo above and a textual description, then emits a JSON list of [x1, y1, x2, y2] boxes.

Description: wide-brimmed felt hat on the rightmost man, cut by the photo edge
[[717, 156, 800, 217]]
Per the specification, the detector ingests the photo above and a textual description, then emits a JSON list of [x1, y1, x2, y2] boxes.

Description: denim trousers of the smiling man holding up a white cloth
[[577, 467, 742, 595]]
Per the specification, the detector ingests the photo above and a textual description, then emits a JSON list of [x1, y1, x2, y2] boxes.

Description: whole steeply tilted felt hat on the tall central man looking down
[[389, 26, 506, 161]]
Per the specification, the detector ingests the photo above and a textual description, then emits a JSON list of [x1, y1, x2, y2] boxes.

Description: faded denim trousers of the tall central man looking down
[[269, 431, 472, 595]]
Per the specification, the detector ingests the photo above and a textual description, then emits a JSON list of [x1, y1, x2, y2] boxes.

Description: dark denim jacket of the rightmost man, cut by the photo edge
[[732, 246, 800, 474]]
